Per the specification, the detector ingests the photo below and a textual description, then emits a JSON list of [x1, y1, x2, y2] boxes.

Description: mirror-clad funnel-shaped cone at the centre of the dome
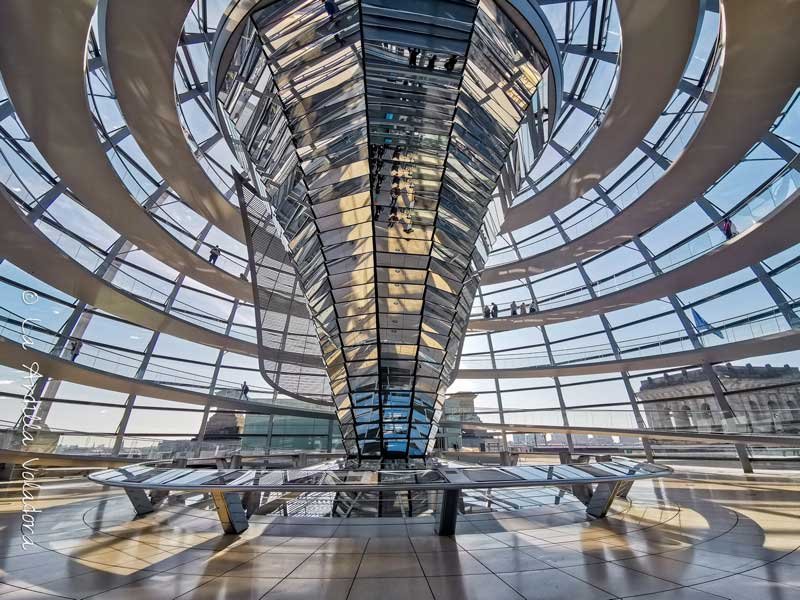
[[225, 0, 546, 459]]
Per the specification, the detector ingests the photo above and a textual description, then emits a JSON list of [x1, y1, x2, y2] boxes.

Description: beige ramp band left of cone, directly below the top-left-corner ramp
[[0, 186, 322, 368]]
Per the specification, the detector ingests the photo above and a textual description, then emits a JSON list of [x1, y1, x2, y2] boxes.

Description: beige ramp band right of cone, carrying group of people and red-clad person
[[469, 186, 800, 331]]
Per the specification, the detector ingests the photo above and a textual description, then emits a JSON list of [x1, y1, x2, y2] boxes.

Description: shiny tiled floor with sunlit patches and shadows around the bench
[[0, 467, 800, 600]]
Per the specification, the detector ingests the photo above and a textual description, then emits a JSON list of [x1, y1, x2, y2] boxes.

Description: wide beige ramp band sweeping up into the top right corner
[[481, 0, 800, 284]]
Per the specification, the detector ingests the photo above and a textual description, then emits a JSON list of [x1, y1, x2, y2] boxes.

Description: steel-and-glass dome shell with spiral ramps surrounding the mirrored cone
[[0, 0, 800, 464]]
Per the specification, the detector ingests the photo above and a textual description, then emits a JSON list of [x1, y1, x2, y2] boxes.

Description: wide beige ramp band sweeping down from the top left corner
[[0, 0, 253, 301]]
